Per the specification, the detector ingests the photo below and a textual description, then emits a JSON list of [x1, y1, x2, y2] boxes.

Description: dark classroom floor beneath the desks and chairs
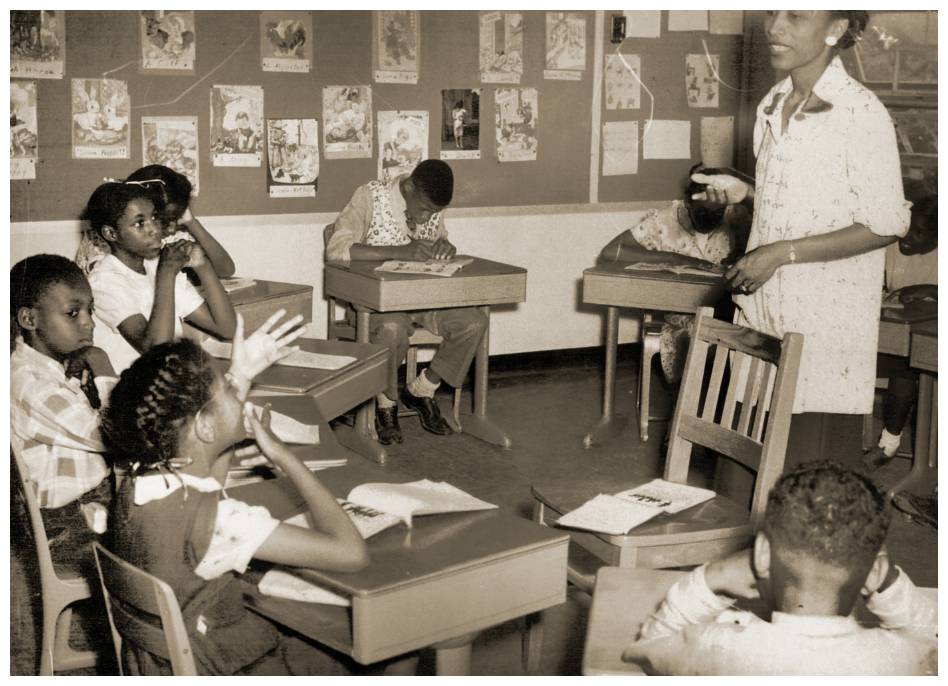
[[10, 346, 938, 675]]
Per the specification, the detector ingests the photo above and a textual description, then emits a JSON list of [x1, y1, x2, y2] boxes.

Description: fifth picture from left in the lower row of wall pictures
[[267, 119, 319, 198]]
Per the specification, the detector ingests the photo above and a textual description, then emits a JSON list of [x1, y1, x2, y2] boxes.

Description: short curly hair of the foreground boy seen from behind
[[764, 460, 891, 575]]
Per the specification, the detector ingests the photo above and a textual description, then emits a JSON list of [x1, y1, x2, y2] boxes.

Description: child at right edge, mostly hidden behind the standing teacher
[[863, 195, 938, 476]]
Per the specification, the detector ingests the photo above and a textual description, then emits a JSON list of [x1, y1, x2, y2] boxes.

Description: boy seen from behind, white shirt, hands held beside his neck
[[622, 461, 938, 675]]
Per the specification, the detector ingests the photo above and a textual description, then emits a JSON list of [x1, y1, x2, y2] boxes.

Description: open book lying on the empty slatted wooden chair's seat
[[557, 479, 715, 536]]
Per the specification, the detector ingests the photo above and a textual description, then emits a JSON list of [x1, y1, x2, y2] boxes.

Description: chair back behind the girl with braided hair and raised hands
[[93, 543, 198, 676]]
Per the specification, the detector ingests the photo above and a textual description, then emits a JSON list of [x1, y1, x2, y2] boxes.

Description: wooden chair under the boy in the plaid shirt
[[10, 449, 97, 676]]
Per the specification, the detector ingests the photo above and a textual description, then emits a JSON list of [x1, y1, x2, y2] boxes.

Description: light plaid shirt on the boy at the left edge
[[10, 339, 116, 508]]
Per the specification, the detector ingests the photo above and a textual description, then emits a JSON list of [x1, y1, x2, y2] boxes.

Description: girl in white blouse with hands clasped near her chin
[[83, 182, 235, 371]]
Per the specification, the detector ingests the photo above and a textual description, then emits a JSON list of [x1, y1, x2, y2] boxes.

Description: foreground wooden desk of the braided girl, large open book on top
[[230, 460, 569, 675]]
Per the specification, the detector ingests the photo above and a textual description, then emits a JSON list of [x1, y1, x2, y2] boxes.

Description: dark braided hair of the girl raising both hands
[[102, 339, 215, 476]]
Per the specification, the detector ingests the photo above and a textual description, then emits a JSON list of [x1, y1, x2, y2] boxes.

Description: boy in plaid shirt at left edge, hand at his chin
[[10, 255, 116, 562]]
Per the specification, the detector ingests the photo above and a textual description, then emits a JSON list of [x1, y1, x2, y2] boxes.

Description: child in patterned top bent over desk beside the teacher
[[599, 163, 750, 383]]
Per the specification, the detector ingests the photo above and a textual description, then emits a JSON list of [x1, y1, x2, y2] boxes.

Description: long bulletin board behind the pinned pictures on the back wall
[[10, 11, 741, 221]]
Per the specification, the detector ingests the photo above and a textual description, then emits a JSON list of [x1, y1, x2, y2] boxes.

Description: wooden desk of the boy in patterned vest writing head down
[[325, 257, 527, 464]]
